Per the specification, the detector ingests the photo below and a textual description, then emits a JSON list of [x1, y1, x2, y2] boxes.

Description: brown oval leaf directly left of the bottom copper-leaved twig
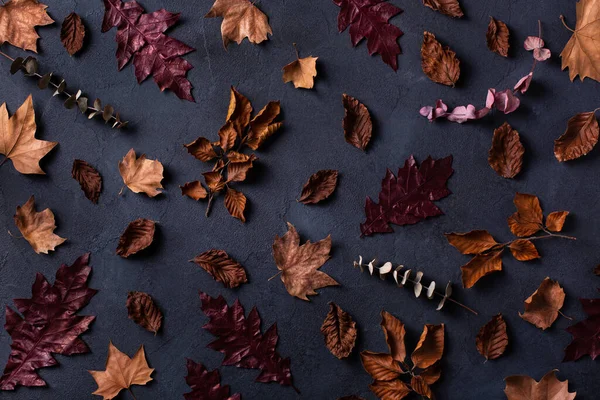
[[321, 302, 357, 360]]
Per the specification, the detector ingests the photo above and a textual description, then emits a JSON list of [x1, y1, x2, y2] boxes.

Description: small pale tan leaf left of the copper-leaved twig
[[119, 149, 163, 197]]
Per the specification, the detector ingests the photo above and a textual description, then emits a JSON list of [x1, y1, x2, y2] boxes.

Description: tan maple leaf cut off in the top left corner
[[0, 0, 54, 53]]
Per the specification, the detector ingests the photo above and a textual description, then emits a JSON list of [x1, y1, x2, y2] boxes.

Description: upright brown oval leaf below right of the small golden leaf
[[342, 93, 373, 151]]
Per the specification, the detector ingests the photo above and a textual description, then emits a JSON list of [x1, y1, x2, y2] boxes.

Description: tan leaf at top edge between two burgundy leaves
[[204, 0, 273, 49]]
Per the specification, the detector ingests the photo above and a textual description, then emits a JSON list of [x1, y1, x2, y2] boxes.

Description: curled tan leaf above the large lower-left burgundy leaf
[[14, 196, 67, 254]]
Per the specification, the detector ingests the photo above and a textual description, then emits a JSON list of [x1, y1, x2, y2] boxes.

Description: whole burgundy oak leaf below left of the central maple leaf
[[200, 292, 297, 391]]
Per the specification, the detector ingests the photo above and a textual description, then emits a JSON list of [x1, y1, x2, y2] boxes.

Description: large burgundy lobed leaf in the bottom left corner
[[0, 253, 97, 390]]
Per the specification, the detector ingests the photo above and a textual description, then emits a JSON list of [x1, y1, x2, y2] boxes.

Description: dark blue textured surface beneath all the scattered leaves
[[0, 0, 600, 400]]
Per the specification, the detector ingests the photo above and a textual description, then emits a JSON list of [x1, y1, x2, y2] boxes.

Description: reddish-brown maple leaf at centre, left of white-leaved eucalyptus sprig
[[273, 222, 339, 301]]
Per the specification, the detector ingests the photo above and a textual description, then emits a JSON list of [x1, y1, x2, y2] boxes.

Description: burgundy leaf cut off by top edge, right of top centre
[[333, 0, 402, 71]]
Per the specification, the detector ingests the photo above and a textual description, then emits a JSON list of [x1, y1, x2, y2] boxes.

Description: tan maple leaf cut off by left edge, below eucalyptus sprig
[[0, 94, 58, 174]]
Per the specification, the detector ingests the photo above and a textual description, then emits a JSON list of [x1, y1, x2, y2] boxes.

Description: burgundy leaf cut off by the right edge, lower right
[[563, 289, 600, 362]]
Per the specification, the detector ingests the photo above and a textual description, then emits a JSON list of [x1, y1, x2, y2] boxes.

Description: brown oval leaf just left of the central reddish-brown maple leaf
[[191, 249, 248, 289]]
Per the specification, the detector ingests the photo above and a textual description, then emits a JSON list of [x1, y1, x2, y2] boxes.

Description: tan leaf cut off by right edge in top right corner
[[560, 0, 600, 82]]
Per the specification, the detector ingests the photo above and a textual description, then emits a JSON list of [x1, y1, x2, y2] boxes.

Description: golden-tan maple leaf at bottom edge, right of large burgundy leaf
[[88, 342, 154, 400]]
